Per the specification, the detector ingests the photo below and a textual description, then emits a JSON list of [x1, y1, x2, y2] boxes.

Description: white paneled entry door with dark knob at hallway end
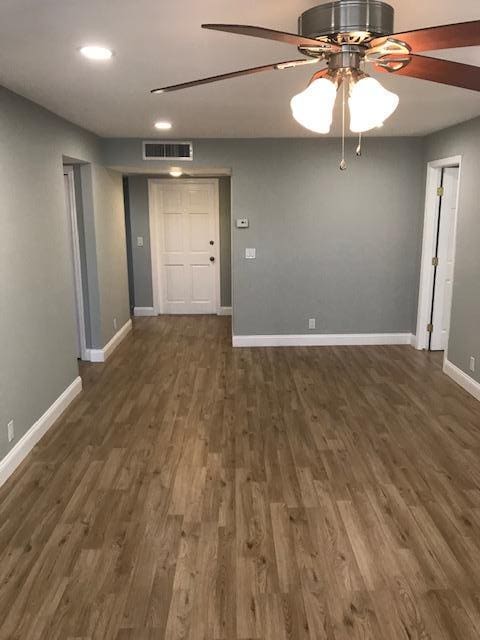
[[151, 180, 219, 314]]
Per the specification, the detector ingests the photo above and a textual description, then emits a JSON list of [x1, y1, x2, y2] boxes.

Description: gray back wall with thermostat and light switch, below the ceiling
[[104, 138, 424, 335]]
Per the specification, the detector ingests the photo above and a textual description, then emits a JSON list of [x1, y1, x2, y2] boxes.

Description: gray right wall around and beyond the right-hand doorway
[[425, 118, 480, 382]]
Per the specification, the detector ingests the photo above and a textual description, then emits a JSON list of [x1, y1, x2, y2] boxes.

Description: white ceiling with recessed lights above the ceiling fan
[[0, 0, 480, 138]]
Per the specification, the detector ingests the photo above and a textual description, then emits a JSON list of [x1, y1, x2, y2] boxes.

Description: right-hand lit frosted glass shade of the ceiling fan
[[348, 78, 399, 133]]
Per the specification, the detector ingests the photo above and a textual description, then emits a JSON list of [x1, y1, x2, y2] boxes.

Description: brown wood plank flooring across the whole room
[[0, 317, 480, 640]]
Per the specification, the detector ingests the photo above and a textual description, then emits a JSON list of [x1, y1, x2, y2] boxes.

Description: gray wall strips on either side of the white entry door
[[127, 175, 232, 307]]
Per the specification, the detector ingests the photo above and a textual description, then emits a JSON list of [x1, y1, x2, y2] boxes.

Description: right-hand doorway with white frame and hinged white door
[[417, 156, 461, 357]]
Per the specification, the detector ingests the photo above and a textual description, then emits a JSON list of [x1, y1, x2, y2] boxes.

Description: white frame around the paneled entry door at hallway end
[[148, 178, 221, 316]]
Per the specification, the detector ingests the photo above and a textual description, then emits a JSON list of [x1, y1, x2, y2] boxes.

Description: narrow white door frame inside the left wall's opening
[[63, 165, 90, 360]]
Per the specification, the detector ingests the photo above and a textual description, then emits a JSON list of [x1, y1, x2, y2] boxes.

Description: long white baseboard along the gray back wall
[[232, 333, 412, 347]]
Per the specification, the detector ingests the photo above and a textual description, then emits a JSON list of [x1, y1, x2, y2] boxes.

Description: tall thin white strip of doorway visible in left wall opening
[[63, 166, 89, 360]]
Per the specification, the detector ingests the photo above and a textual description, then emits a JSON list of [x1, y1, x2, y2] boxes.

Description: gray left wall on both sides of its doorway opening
[[0, 88, 129, 459]]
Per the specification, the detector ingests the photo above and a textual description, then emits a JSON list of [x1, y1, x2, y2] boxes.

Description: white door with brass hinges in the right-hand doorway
[[430, 167, 459, 351]]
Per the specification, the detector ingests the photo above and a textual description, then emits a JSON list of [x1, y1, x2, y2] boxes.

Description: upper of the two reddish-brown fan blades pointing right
[[370, 20, 480, 53]]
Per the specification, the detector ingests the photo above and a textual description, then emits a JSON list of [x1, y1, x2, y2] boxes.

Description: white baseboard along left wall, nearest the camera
[[0, 377, 82, 487]]
